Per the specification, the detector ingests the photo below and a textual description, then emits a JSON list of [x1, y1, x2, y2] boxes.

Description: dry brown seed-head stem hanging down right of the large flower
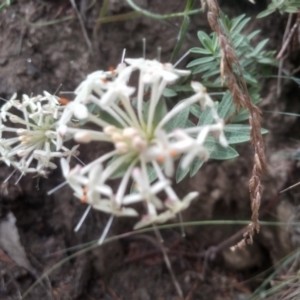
[[201, 0, 266, 250]]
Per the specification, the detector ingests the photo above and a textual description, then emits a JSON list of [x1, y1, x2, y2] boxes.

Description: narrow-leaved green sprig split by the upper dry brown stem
[[187, 15, 276, 88]]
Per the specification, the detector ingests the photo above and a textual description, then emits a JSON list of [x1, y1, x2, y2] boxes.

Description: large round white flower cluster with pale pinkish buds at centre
[[58, 58, 227, 229]]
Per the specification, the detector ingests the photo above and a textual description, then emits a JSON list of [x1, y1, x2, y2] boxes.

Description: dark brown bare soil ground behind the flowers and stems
[[0, 0, 300, 300]]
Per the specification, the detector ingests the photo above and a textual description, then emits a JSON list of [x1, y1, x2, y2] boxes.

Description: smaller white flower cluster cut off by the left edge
[[0, 92, 78, 176]]
